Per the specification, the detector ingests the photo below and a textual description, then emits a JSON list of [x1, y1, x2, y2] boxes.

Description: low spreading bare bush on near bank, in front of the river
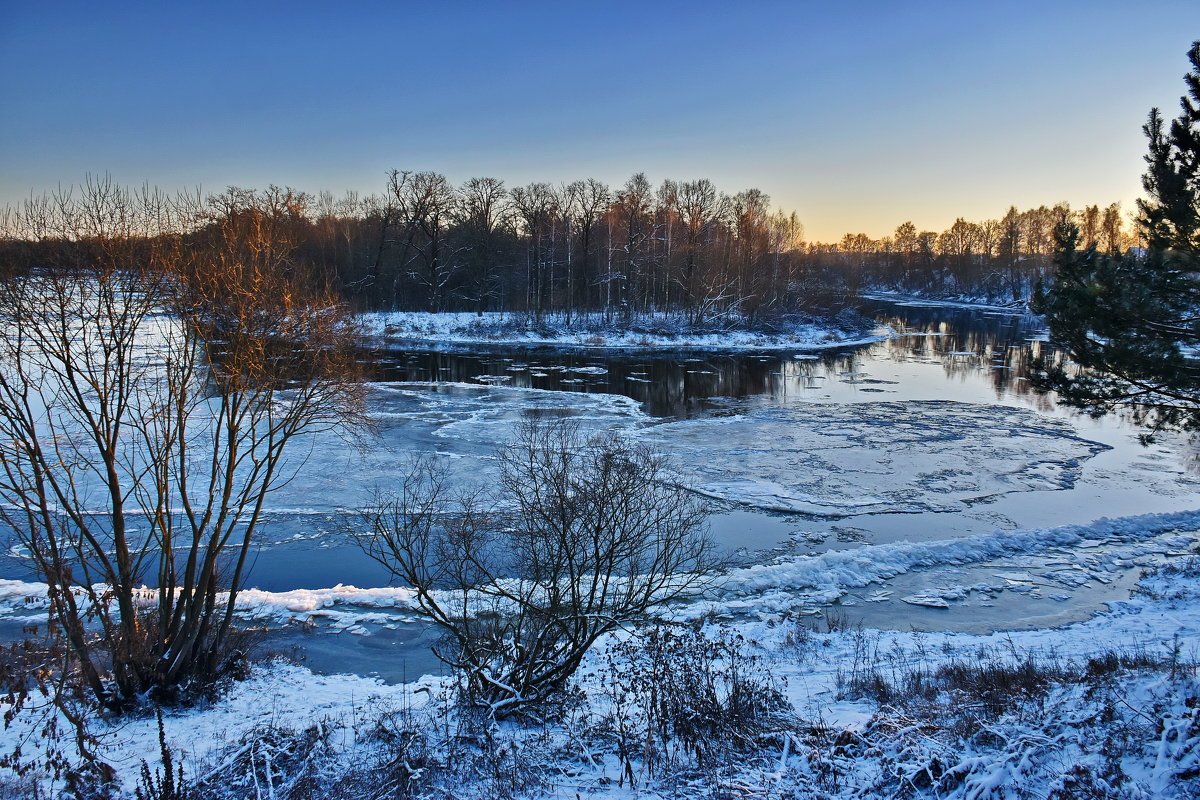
[[355, 421, 712, 717]]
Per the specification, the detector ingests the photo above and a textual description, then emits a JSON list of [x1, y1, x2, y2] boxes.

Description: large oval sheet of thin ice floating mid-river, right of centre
[[647, 402, 1108, 517]]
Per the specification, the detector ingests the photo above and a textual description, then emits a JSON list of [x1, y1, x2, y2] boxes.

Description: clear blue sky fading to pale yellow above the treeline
[[0, 0, 1200, 241]]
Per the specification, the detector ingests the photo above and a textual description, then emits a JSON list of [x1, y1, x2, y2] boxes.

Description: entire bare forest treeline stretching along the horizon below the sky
[[0, 170, 1136, 325]]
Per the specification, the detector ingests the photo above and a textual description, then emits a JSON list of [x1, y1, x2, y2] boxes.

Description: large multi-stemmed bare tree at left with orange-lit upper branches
[[0, 181, 361, 708]]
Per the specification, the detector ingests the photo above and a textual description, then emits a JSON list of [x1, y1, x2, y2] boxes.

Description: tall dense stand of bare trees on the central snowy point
[[302, 170, 808, 324]]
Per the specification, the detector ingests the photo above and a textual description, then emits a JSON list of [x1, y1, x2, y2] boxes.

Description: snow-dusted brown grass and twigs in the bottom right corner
[[816, 649, 1200, 800]]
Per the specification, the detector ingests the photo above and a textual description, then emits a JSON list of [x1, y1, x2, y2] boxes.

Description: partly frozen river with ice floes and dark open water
[[0, 305, 1200, 680]]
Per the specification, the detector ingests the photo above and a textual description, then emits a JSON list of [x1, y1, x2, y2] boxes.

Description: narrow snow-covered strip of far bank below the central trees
[[361, 311, 893, 353]]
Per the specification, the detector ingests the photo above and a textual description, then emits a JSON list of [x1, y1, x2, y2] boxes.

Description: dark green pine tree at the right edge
[[1032, 41, 1200, 429]]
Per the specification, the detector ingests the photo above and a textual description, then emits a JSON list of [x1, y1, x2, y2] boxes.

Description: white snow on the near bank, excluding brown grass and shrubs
[[9, 554, 1200, 800]]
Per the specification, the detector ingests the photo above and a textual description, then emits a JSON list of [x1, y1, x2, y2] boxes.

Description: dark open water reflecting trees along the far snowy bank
[[362, 303, 1060, 417]]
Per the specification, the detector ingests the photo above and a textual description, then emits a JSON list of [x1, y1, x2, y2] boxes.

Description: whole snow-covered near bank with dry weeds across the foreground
[[0, 551, 1200, 800]]
